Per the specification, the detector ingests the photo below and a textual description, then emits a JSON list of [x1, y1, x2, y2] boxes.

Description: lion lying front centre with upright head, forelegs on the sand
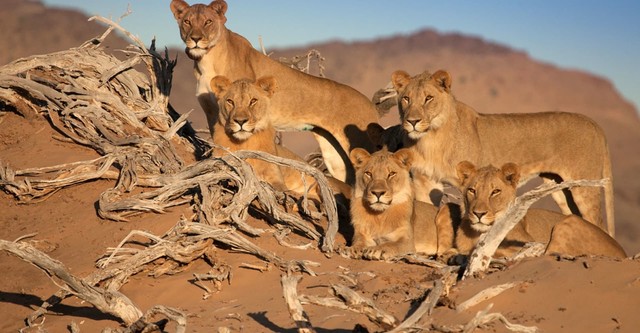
[[350, 148, 453, 259]]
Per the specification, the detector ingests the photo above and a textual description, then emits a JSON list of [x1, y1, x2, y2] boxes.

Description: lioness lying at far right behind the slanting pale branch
[[455, 161, 627, 258]]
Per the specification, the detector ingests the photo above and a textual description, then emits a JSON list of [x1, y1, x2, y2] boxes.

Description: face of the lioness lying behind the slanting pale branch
[[457, 161, 520, 233]]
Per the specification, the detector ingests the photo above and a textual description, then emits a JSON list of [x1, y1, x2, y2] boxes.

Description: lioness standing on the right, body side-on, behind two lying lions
[[391, 70, 614, 236]]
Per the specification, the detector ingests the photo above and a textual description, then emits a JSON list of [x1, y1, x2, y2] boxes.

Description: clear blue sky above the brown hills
[[43, 0, 640, 109]]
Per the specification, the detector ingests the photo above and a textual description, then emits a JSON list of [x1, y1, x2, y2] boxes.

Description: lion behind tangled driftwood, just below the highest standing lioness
[[210, 75, 351, 199]]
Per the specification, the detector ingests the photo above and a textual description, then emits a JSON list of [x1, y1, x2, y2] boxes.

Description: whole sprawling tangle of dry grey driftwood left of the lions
[[0, 13, 338, 332]]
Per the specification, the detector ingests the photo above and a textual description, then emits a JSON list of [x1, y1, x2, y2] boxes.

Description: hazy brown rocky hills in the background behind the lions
[[0, 0, 640, 253]]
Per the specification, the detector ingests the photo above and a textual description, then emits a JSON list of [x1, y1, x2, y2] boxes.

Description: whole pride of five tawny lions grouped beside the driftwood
[[170, 0, 626, 259]]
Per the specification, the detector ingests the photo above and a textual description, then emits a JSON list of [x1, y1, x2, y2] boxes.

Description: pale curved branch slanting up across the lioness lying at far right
[[463, 179, 609, 278]]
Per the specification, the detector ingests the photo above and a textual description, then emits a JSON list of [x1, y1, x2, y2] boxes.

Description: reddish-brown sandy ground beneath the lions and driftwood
[[0, 113, 640, 332]]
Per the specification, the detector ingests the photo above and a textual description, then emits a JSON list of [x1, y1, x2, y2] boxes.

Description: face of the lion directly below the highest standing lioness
[[211, 76, 276, 141]]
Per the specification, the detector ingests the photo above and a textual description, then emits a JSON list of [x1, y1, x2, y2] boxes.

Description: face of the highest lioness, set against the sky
[[171, 0, 227, 60]]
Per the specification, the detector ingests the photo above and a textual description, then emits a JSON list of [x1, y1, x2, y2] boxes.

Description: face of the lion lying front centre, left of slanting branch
[[350, 148, 413, 212]]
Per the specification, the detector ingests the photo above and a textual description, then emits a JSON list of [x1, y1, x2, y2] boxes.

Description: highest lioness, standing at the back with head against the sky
[[171, 0, 378, 184]]
